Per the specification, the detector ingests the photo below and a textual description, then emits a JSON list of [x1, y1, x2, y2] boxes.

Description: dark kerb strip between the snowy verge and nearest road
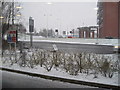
[[0, 67, 120, 90]]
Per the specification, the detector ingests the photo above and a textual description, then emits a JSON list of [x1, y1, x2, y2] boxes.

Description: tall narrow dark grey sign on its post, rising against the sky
[[29, 17, 34, 48]]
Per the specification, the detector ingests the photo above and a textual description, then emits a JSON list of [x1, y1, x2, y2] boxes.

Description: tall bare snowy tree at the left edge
[[0, 1, 21, 50]]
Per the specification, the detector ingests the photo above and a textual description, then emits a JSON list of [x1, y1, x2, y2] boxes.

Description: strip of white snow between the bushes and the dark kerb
[[0, 64, 120, 86]]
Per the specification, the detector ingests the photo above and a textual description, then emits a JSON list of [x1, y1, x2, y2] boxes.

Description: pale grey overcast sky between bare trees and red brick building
[[22, 2, 97, 33]]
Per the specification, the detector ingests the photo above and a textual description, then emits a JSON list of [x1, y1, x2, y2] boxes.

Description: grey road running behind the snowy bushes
[[20, 41, 114, 54]]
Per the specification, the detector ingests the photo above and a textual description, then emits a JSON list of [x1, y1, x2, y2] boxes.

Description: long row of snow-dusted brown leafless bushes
[[2, 49, 119, 78]]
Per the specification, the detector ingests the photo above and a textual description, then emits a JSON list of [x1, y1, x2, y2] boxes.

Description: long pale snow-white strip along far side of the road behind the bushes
[[21, 36, 119, 45]]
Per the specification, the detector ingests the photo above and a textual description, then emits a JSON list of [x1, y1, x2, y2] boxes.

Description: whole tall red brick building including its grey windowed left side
[[97, 2, 120, 38]]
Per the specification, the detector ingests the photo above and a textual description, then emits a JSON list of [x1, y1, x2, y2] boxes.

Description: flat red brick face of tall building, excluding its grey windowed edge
[[100, 2, 118, 38]]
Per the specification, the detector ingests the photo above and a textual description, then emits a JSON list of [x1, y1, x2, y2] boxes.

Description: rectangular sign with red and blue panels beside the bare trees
[[7, 30, 16, 43]]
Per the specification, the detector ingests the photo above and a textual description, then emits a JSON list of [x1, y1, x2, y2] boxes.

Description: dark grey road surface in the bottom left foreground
[[0, 70, 95, 88]]
